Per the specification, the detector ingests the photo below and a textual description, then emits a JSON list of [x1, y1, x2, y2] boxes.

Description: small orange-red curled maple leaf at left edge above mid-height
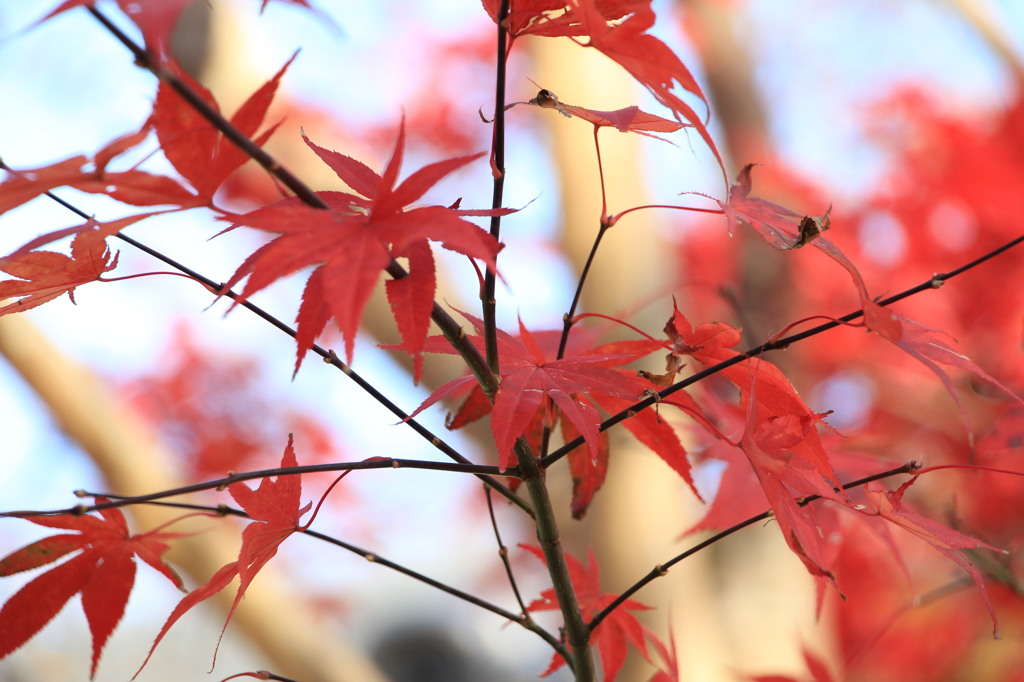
[[0, 216, 130, 315]]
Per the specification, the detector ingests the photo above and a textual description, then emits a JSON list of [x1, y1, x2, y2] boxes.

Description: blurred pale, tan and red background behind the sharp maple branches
[[0, 0, 1024, 681]]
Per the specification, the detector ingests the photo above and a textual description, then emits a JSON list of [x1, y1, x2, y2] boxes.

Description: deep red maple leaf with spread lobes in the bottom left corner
[[0, 498, 184, 677]]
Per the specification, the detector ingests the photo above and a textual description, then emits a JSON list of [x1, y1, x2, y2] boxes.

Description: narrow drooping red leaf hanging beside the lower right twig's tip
[[860, 476, 1007, 638]]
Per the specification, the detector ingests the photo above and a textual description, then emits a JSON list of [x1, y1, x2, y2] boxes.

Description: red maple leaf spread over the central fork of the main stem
[[399, 310, 662, 469]]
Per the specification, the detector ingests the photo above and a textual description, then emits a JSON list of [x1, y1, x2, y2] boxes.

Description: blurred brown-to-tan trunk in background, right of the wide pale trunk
[[679, 0, 827, 676]]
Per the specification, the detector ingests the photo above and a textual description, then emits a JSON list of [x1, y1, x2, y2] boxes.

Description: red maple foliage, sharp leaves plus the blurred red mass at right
[[0, 0, 1024, 682]]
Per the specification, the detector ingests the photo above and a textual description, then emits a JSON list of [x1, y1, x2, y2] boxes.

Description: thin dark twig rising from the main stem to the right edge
[[541, 235, 1024, 467]]
